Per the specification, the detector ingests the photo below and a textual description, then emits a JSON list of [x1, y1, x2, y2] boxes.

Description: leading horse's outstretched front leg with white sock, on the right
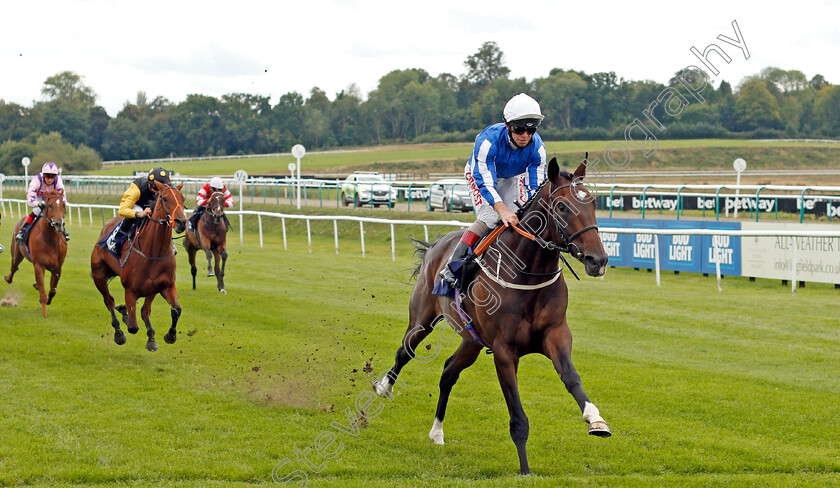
[[543, 320, 612, 437]]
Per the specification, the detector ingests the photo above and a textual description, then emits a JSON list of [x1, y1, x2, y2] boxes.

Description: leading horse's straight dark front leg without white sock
[[493, 343, 531, 474]]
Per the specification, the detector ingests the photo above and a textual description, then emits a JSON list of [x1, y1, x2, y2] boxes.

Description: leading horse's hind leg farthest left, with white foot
[[373, 293, 442, 398]]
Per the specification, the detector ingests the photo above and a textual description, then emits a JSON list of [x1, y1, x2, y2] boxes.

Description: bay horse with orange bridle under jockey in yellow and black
[[90, 183, 187, 351]]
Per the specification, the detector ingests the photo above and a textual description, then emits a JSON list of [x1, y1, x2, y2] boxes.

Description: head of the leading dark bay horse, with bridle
[[540, 158, 609, 276]]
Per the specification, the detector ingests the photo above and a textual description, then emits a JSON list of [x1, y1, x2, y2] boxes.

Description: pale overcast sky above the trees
[[0, 0, 840, 116]]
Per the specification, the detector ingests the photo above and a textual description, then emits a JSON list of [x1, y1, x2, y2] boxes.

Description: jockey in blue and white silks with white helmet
[[440, 93, 546, 287]]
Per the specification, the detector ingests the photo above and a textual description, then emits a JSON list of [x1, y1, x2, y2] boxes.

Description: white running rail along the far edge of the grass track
[[0, 199, 840, 295]]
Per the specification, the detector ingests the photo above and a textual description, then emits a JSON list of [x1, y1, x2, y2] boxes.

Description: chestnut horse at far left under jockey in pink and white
[[5, 190, 67, 318]]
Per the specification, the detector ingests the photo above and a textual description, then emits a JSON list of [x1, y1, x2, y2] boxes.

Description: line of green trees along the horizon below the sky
[[0, 42, 840, 173]]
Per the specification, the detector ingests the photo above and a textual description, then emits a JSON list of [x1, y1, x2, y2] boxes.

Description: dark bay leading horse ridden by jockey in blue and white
[[374, 158, 611, 474]]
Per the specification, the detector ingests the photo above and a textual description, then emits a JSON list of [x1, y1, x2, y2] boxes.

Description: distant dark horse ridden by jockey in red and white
[[184, 191, 228, 294]]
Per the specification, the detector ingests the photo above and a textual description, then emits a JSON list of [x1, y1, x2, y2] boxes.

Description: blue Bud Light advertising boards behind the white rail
[[598, 219, 741, 276]]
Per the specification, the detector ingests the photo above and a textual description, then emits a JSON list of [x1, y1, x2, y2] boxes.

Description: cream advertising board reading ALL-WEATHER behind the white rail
[[741, 222, 840, 283]]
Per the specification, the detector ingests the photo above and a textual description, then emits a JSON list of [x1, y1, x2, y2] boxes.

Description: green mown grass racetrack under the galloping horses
[[0, 226, 840, 487]]
